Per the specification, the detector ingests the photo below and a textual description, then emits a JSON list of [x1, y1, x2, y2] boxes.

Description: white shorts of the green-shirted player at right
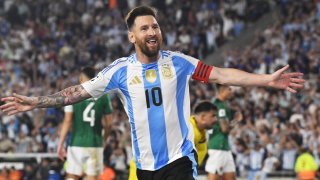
[[205, 149, 236, 175]]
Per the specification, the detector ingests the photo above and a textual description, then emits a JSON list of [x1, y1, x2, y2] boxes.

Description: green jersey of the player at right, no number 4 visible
[[208, 99, 231, 151]]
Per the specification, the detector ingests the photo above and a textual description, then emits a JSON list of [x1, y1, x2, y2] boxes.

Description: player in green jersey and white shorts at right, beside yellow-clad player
[[205, 85, 243, 180]]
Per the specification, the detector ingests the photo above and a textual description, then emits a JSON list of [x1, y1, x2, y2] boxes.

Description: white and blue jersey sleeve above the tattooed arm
[[81, 58, 126, 98]]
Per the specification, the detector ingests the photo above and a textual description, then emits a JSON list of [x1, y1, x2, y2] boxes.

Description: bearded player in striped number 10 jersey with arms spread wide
[[0, 6, 304, 180]]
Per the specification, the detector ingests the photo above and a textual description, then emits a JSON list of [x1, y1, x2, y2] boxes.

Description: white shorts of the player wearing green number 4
[[66, 146, 103, 176]]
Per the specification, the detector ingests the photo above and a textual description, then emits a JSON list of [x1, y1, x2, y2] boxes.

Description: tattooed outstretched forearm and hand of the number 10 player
[[0, 85, 91, 115]]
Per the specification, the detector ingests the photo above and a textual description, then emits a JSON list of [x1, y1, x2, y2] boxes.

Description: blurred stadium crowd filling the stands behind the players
[[0, 0, 320, 179]]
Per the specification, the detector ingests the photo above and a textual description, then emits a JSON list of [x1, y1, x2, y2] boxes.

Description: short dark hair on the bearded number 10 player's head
[[125, 6, 157, 29]]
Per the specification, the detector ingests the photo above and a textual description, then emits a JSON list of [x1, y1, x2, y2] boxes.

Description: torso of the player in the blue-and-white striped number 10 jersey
[[118, 53, 193, 169]]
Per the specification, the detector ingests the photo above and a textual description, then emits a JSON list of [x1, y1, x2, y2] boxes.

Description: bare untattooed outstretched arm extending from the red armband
[[209, 65, 305, 93]]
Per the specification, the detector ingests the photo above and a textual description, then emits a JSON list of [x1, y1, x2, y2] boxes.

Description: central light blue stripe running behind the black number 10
[[142, 63, 169, 169]]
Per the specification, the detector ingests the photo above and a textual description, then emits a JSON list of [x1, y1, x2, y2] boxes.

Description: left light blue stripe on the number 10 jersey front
[[106, 66, 141, 169]]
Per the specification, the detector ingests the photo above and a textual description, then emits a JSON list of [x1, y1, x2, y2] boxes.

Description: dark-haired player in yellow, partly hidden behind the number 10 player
[[129, 101, 217, 180]]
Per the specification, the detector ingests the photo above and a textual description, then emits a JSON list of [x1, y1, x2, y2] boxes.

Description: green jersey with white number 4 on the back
[[65, 94, 112, 147]]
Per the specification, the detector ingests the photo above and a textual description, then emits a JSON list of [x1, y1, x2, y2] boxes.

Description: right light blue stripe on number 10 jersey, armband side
[[172, 56, 194, 156]]
